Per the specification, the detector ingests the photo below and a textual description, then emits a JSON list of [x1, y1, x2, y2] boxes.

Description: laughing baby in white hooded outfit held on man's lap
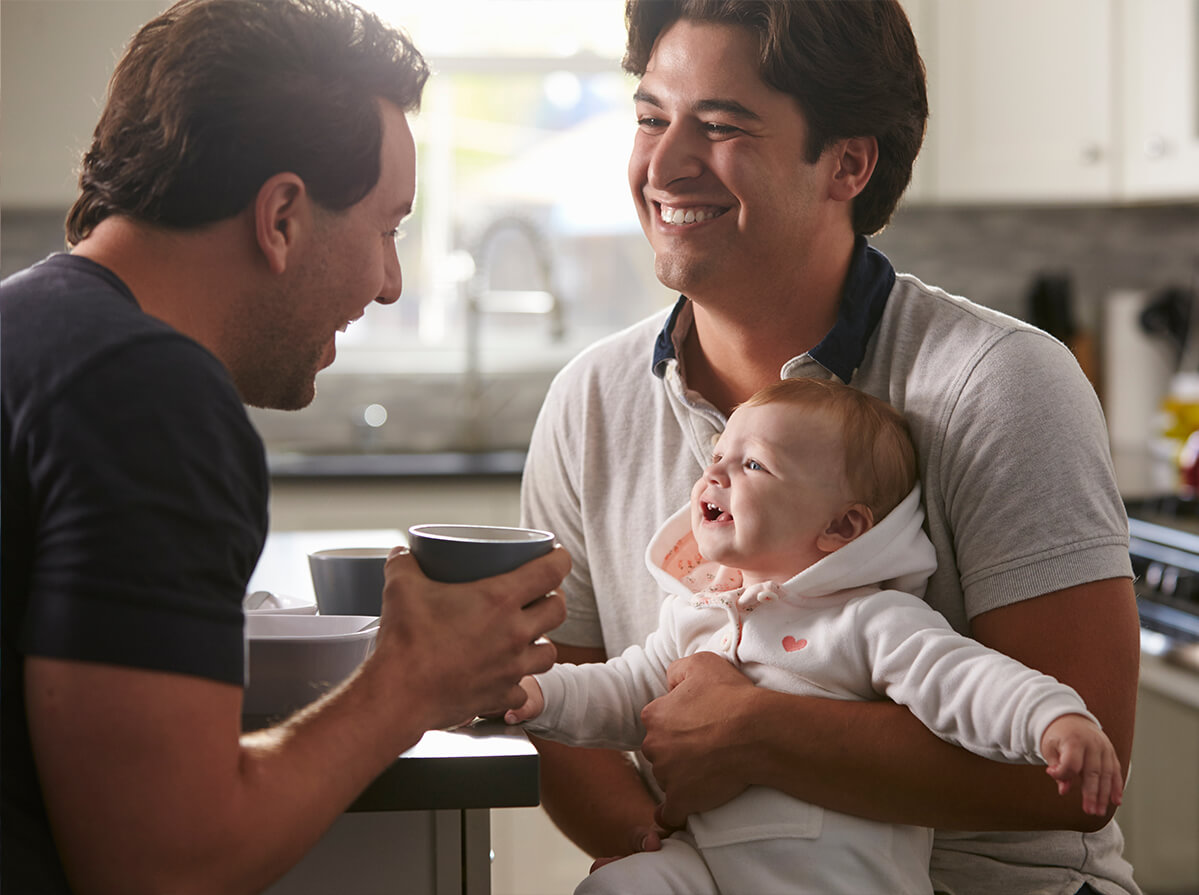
[[506, 379, 1123, 895]]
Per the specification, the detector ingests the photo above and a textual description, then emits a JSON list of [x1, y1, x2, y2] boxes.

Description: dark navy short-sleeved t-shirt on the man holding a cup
[[0, 254, 269, 893]]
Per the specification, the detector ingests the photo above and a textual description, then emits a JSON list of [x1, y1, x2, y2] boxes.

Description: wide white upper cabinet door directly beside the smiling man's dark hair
[[921, 0, 1117, 203]]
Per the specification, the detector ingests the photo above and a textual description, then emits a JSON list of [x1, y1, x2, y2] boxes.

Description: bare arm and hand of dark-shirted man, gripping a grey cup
[[25, 551, 568, 895]]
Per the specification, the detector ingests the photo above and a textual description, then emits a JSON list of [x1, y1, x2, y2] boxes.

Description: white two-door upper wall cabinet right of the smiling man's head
[[909, 0, 1199, 204]]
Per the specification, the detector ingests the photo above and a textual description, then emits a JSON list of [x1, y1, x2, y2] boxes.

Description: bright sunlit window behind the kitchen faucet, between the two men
[[338, 0, 649, 359]]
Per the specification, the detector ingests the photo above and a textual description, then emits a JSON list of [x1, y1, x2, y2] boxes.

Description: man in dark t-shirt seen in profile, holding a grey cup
[[0, 0, 570, 895]]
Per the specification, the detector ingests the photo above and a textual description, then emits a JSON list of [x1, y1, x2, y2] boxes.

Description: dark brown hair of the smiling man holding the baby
[[623, 0, 928, 235]]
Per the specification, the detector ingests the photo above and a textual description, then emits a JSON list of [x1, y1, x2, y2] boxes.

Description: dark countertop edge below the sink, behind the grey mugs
[[266, 450, 525, 481]]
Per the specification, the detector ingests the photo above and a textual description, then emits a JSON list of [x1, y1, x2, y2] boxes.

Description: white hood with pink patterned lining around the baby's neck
[[645, 485, 936, 599]]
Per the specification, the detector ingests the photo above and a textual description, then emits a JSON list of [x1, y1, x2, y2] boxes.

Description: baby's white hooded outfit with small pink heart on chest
[[526, 486, 1097, 895]]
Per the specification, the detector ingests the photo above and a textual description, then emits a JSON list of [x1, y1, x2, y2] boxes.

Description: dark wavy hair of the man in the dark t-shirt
[[66, 0, 429, 245]]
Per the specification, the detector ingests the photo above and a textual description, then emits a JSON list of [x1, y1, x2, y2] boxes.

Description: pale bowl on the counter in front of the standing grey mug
[[242, 613, 379, 717]]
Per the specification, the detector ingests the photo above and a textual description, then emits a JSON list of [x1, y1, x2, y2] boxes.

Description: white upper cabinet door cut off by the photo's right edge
[[1119, 0, 1199, 199]]
